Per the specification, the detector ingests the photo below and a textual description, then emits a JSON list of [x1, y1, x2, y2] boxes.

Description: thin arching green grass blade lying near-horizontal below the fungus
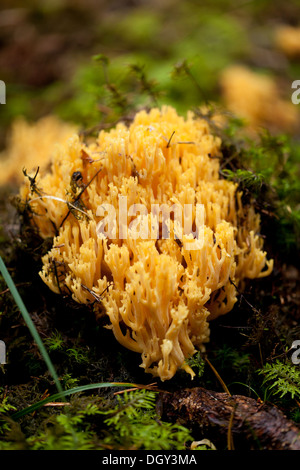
[[11, 382, 141, 420]]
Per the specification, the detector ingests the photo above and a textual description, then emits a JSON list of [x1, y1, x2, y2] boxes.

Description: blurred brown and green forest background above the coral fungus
[[0, 0, 300, 143]]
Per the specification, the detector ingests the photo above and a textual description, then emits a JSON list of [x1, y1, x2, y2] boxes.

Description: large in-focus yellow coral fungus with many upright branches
[[21, 107, 273, 380]]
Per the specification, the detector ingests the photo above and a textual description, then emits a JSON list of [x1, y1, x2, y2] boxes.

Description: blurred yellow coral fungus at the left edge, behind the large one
[[0, 116, 77, 185]]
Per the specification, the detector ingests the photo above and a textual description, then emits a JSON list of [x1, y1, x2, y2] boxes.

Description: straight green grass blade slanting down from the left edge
[[0, 256, 63, 393]]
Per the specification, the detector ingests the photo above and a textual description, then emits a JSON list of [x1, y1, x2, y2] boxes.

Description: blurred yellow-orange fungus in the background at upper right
[[220, 65, 300, 134]]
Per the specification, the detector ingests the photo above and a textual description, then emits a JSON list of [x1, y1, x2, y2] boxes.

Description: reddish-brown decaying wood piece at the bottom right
[[159, 387, 300, 450]]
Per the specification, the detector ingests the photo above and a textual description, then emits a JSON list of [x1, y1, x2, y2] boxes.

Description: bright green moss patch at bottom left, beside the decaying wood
[[0, 390, 192, 450]]
